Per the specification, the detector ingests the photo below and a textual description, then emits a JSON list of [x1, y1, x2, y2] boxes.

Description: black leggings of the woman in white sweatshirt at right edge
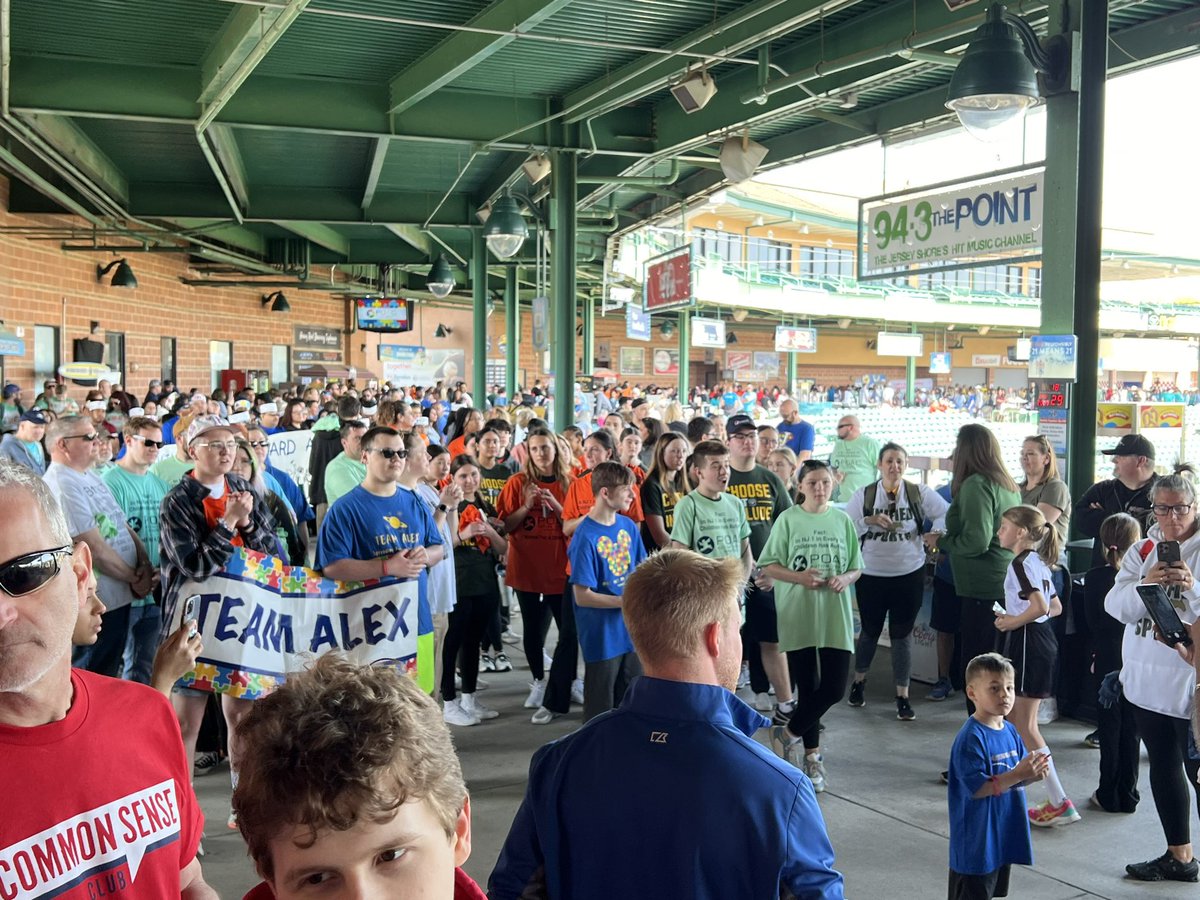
[[1132, 703, 1200, 847]]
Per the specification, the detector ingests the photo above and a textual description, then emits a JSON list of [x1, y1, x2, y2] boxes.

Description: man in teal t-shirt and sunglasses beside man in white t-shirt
[[101, 416, 170, 684]]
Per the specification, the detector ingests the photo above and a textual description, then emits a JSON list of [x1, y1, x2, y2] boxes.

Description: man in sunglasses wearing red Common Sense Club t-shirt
[[0, 460, 217, 900]]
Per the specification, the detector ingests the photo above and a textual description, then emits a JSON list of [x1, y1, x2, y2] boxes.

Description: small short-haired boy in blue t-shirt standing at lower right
[[947, 653, 1049, 900]]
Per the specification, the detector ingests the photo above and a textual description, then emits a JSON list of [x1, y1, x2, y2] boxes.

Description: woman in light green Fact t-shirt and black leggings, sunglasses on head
[[758, 460, 863, 792]]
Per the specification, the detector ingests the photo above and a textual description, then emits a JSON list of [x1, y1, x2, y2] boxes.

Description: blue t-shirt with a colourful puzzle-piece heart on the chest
[[566, 515, 646, 662]]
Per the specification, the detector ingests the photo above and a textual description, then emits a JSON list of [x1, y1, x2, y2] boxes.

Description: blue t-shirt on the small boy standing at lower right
[[949, 716, 1033, 875]]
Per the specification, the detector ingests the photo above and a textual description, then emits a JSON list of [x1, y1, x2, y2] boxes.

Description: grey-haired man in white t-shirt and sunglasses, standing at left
[[46, 415, 155, 678]]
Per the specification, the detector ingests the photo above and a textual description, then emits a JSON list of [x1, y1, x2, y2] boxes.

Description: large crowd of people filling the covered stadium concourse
[[0, 367, 1200, 899]]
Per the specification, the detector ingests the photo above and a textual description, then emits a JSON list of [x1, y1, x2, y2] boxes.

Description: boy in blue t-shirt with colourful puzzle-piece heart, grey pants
[[568, 462, 646, 721]]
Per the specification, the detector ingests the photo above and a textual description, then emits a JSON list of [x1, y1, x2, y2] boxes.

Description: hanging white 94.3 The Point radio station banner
[[858, 167, 1045, 281]]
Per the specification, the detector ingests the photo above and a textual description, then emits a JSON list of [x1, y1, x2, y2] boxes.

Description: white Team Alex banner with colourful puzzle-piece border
[[175, 548, 422, 700]]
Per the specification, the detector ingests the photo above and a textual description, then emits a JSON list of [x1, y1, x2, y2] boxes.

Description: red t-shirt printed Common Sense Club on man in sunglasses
[[0, 670, 204, 900]]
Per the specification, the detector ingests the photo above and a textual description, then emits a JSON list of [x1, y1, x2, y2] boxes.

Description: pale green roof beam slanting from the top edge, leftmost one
[[196, 0, 310, 132]]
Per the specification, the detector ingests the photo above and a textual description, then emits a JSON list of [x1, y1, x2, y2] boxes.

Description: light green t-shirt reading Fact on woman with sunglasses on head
[[758, 506, 863, 652]]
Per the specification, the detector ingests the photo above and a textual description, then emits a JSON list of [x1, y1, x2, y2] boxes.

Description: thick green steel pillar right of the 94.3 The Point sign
[[1040, 0, 1109, 497]]
